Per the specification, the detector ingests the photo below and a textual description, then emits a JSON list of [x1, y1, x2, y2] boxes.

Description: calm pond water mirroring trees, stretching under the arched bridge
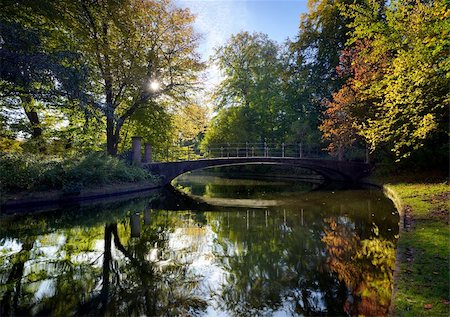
[[0, 167, 398, 316]]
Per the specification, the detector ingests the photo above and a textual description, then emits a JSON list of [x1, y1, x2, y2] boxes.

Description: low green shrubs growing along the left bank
[[0, 153, 152, 193]]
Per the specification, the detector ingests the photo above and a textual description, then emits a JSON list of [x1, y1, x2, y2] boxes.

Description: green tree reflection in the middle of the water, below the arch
[[209, 210, 346, 316]]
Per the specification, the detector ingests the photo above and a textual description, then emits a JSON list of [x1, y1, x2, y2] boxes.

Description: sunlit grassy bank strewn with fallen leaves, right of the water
[[377, 175, 450, 316]]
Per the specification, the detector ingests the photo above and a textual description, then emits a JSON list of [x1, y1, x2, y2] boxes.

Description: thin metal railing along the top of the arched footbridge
[[152, 142, 367, 162]]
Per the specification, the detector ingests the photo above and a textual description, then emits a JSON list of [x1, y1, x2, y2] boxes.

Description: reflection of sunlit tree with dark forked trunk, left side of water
[[0, 211, 205, 316]]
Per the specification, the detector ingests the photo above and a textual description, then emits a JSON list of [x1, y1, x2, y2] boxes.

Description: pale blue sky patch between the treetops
[[175, 0, 307, 86]]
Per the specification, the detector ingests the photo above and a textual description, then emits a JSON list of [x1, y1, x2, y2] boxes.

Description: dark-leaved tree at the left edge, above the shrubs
[[0, 14, 86, 151]]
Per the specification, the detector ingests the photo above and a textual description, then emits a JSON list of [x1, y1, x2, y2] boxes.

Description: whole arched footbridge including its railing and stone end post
[[127, 138, 372, 185]]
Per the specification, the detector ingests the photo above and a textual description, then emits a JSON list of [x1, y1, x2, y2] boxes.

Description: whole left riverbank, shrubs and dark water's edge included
[[0, 152, 161, 214]]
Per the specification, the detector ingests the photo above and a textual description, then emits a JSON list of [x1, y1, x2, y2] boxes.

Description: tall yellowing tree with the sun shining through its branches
[[59, 0, 202, 155]]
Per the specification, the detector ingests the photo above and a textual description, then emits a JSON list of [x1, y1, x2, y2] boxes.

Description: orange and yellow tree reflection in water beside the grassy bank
[[322, 217, 395, 316]]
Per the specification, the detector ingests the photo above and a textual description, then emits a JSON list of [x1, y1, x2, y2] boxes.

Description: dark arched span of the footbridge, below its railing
[[143, 157, 372, 185]]
